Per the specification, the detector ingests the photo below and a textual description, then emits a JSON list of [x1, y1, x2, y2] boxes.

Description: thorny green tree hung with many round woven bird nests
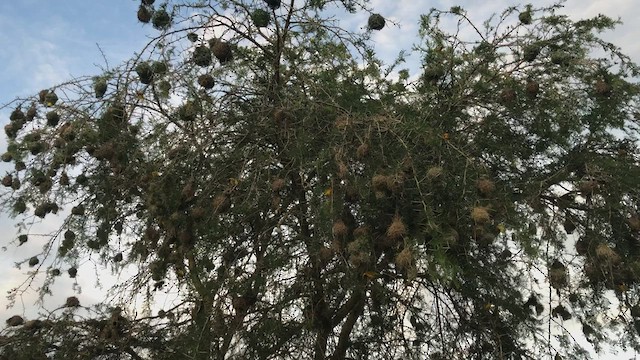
[[0, 0, 640, 359]]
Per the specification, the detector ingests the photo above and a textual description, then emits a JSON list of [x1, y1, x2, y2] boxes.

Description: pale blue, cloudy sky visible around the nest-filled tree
[[0, 0, 640, 359]]
